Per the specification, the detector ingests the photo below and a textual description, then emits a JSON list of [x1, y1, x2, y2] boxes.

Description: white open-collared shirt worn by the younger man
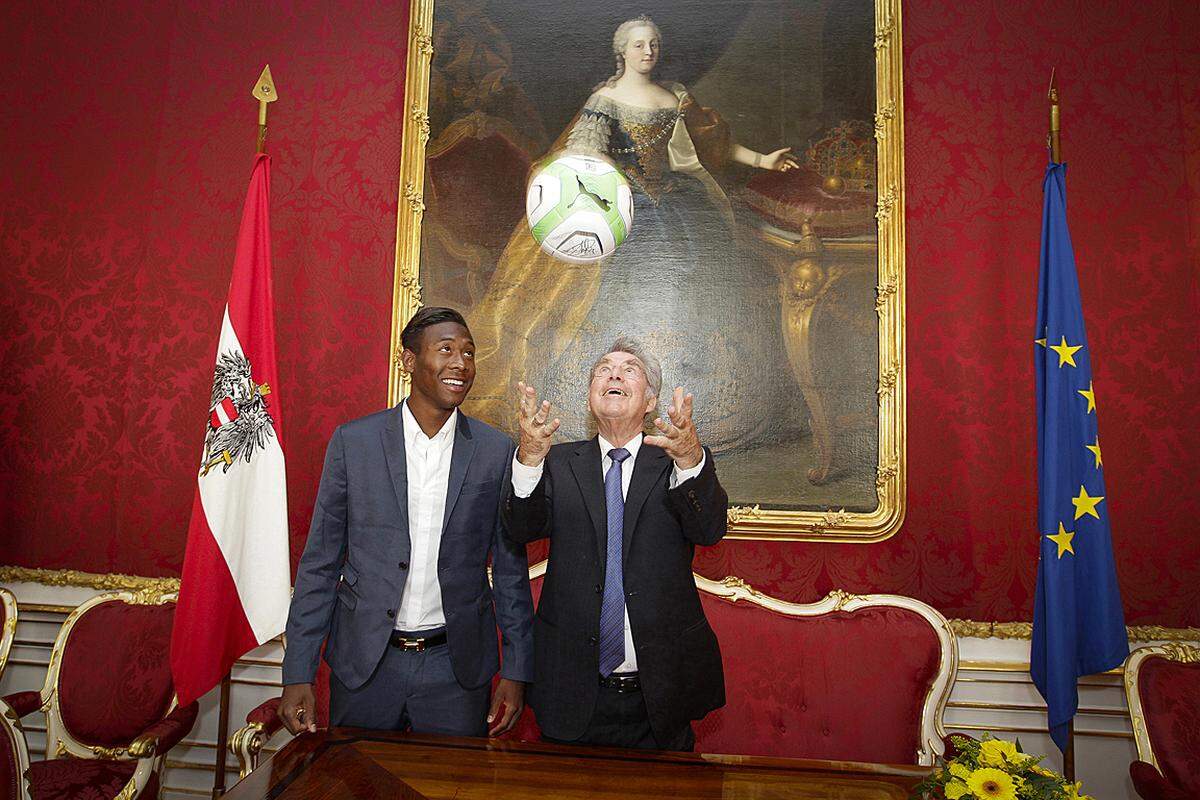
[[396, 401, 458, 631]]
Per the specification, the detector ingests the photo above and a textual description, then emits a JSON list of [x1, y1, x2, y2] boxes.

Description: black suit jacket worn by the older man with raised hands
[[503, 439, 728, 740]]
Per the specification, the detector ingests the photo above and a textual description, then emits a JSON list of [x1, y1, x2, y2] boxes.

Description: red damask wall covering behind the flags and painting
[[0, 0, 1200, 626]]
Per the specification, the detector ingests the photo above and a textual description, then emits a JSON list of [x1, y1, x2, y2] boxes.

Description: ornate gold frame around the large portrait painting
[[386, 0, 907, 543]]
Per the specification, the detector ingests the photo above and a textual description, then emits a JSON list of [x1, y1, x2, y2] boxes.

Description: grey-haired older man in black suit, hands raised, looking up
[[503, 339, 728, 750]]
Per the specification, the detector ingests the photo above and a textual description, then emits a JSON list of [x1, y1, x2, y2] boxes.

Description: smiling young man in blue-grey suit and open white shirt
[[278, 308, 533, 736]]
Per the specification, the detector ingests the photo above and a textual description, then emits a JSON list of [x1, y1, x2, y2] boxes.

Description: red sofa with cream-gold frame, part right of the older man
[[696, 576, 959, 765]]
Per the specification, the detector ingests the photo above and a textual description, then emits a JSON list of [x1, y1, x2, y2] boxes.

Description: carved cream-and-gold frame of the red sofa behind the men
[[529, 561, 959, 766]]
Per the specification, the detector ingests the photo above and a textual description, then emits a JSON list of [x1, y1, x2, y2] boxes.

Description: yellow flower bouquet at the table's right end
[[913, 733, 1092, 800]]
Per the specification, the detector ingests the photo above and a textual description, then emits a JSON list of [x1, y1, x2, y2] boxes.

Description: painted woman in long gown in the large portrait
[[467, 17, 797, 453]]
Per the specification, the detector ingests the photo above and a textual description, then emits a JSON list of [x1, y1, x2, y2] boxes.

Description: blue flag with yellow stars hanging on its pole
[[1030, 163, 1129, 751]]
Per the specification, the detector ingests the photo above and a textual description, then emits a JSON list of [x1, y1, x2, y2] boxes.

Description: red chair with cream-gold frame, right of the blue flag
[[1124, 642, 1200, 800]]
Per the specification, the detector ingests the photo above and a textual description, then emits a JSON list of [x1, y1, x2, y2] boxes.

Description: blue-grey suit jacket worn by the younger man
[[283, 405, 533, 688]]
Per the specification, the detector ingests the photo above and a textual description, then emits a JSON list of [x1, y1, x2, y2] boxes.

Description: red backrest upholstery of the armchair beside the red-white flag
[[59, 601, 175, 747]]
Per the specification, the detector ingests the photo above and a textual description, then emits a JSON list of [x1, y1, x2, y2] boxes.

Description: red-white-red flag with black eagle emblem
[[170, 154, 290, 705]]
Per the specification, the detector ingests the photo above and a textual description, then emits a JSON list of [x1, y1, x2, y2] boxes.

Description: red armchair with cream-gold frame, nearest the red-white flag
[[4, 589, 198, 800]]
